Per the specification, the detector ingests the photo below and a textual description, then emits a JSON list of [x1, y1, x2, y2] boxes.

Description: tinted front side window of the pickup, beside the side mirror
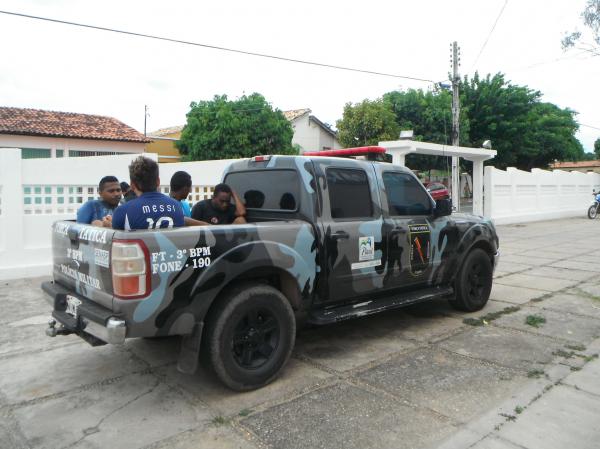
[[383, 172, 431, 215]]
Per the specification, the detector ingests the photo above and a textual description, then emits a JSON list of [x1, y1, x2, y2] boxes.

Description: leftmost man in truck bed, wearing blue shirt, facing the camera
[[77, 176, 121, 228]]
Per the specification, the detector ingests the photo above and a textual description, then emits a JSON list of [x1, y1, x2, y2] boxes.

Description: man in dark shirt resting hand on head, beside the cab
[[192, 184, 246, 224]]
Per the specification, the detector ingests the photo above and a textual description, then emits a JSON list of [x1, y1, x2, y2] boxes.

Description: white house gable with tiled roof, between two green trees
[[283, 109, 342, 153]]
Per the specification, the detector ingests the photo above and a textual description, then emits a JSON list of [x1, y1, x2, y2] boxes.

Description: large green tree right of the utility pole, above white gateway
[[460, 73, 583, 170]]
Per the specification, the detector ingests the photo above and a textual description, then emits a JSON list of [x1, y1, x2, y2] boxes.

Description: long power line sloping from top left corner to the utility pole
[[0, 11, 434, 83]]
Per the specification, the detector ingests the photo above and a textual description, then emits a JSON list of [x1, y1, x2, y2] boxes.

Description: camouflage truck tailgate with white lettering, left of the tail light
[[52, 221, 115, 309]]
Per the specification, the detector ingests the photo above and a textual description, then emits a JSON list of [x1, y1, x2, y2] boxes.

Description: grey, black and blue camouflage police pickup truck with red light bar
[[42, 156, 499, 390]]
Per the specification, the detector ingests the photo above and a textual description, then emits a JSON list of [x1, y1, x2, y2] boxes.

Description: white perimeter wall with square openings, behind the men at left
[[0, 148, 239, 280]]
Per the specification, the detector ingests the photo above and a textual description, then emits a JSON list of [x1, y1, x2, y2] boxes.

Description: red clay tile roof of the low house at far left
[[0, 107, 151, 143]]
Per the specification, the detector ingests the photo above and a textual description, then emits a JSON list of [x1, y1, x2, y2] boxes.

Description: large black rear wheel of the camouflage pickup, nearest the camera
[[207, 284, 296, 391]]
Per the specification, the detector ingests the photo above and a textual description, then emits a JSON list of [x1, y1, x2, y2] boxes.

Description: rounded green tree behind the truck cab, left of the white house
[[178, 93, 297, 161]]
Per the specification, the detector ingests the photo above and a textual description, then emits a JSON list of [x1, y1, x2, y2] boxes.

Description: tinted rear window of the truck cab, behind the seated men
[[225, 170, 300, 210]]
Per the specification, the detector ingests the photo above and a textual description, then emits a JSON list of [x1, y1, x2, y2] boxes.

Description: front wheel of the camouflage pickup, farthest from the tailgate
[[450, 248, 493, 312]]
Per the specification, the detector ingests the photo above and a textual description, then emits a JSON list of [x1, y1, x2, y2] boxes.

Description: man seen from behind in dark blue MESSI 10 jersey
[[112, 156, 184, 231]]
